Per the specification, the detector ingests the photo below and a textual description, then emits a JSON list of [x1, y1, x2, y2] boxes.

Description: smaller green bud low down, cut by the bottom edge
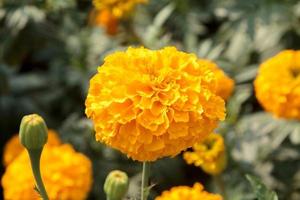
[[104, 170, 129, 200]]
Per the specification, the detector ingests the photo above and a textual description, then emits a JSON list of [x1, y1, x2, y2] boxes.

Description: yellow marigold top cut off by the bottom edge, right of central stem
[[155, 183, 223, 200]]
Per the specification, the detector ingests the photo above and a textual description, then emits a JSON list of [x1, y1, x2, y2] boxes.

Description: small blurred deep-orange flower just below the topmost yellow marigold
[[90, 10, 118, 35]]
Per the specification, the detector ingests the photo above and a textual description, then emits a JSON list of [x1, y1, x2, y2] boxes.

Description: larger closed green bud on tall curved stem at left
[[19, 114, 48, 150]]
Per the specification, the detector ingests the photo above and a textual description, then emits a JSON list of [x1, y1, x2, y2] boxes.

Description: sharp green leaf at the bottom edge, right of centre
[[246, 175, 278, 200]]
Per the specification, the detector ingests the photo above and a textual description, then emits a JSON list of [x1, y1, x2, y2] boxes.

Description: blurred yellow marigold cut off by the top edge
[[93, 0, 148, 18]]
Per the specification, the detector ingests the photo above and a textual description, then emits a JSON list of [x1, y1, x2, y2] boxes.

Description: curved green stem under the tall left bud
[[28, 148, 49, 200]]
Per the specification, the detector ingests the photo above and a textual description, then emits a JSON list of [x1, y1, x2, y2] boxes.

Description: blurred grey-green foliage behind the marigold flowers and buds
[[0, 0, 300, 200]]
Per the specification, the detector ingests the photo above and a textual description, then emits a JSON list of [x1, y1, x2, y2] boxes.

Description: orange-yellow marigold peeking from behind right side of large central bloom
[[199, 59, 234, 100]]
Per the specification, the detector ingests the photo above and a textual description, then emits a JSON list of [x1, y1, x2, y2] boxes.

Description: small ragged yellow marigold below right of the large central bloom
[[183, 133, 227, 175]]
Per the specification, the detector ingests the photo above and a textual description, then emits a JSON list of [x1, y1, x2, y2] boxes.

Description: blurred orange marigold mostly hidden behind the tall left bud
[[3, 130, 61, 166]]
